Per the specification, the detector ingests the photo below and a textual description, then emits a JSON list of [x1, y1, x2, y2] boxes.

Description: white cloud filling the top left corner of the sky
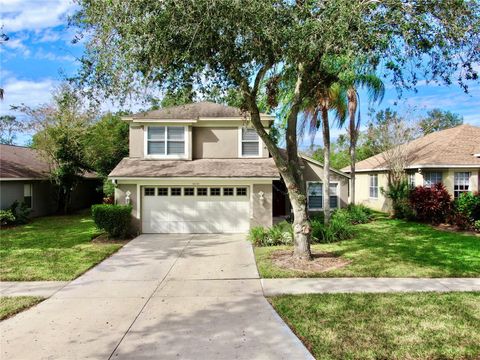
[[0, 0, 76, 34]]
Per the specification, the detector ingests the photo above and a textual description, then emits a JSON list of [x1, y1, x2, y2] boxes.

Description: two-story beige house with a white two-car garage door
[[109, 102, 348, 233]]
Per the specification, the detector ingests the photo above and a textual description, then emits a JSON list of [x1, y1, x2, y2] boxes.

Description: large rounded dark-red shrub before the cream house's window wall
[[409, 183, 452, 224]]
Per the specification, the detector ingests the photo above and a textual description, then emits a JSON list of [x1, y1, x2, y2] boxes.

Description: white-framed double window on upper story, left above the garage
[[146, 126, 186, 157]]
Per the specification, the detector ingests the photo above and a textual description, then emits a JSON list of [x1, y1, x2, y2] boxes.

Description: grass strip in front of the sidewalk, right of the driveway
[[269, 292, 480, 359]]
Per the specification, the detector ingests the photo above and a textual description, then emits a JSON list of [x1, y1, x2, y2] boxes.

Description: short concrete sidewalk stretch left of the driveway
[[0, 281, 68, 298]]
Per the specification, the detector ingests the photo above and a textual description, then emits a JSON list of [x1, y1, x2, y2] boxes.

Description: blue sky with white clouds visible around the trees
[[0, 0, 480, 143]]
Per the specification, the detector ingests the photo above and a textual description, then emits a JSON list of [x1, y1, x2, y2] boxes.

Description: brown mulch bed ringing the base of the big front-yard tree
[[270, 250, 351, 272]]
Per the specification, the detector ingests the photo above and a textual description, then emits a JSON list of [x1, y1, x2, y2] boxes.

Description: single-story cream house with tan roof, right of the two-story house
[[342, 125, 480, 211]]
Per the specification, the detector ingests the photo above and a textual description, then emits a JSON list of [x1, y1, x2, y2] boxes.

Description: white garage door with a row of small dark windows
[[142, 186, 250, 234]]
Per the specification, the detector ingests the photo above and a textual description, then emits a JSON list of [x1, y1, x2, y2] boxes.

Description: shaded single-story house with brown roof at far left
[[0, 145, 101, 217]]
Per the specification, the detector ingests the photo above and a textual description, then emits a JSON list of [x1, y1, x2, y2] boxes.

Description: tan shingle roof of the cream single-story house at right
[[342, 124, 480, 172]]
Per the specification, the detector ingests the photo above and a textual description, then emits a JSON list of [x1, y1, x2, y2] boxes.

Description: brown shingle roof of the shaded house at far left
[[0, 145, 50, 180]]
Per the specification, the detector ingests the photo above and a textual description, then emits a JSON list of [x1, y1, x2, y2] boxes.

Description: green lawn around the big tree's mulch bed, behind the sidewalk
[[255, 217, 480, 278]]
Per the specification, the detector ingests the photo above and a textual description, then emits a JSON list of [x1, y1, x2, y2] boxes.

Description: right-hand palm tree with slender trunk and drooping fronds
[[347, 73, 385, 204]]
